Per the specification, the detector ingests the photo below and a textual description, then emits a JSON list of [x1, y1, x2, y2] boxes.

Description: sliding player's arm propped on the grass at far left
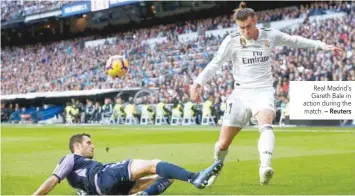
[[33, 154, 74, 195]]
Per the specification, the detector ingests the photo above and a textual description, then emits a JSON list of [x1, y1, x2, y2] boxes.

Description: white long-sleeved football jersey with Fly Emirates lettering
[[196, 28, 325, 88]]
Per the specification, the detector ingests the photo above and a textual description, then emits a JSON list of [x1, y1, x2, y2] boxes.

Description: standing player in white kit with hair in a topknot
[[190, 2, 342, 186]]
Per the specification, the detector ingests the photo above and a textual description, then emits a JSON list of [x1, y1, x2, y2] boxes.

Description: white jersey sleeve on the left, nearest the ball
[[196, 36, 232, 86]]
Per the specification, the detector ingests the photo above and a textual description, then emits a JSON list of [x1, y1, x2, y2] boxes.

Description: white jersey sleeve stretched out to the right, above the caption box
[[273, 29, 325, 49]]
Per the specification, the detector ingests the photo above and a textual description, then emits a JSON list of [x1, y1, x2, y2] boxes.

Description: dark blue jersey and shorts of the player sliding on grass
[[53, 154, 135, 195]]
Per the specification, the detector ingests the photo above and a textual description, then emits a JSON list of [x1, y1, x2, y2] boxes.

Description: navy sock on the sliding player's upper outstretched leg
[[156, 161, 195, 182]]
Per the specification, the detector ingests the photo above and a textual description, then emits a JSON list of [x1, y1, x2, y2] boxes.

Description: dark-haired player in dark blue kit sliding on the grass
[[34, 133, 221, 195]]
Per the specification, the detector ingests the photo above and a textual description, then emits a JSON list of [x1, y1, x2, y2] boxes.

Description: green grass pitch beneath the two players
[[1, 126, 355, 195]]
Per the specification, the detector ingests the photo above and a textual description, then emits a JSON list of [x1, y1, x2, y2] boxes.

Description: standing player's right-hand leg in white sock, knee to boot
[[256, 109, 275, 185]]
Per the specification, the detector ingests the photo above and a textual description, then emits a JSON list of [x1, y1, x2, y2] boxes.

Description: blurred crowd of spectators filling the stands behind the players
[[1, 1, 355, 125]]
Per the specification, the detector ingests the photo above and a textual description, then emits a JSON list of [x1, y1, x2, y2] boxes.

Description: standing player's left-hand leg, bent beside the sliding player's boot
[[207, 126, 241, 187]]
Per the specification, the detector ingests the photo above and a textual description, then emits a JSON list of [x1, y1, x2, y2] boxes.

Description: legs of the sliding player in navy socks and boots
[[130, 159, 220, 195]]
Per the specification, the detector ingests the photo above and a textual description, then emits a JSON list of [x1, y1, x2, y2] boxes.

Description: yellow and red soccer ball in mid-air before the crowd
[[106, 55, 129, 78]]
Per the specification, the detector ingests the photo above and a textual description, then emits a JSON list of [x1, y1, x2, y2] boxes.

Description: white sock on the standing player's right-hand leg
[[258, 124, 275, 167]]
